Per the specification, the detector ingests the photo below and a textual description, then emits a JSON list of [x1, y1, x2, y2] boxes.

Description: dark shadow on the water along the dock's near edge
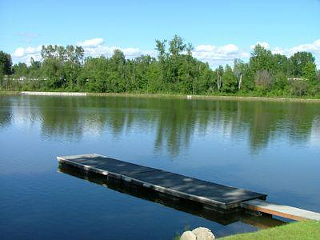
[[58, 163, 285, 229]]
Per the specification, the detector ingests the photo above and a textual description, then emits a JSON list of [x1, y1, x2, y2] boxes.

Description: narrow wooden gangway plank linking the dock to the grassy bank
[[241, 199, 320, 221]]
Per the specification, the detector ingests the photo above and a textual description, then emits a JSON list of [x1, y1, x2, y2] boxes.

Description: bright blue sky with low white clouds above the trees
[[0, 0, 320, 66]]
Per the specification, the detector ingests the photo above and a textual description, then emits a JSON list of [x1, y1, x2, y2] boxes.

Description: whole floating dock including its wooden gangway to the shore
[[57, 154, 320, 221]]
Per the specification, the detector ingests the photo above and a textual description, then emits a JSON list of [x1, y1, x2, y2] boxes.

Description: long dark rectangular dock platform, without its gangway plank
[[58, 154, 266, 210]]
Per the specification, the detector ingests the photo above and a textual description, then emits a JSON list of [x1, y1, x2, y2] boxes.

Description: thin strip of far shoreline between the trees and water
[[0, 91, 320, 103]]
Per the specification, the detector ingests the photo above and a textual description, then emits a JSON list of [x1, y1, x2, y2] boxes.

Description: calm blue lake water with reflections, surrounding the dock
[[0, 96, 320, 239]]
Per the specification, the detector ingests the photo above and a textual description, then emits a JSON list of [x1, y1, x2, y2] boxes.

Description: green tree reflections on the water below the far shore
[[0, 96, 320, 156]]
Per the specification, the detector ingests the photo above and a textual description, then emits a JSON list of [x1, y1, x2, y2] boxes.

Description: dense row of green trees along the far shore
[[0, 36, 320, 97]]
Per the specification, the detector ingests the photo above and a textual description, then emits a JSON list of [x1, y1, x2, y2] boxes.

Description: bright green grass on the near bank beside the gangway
[[220, 221, 320, 240]]
